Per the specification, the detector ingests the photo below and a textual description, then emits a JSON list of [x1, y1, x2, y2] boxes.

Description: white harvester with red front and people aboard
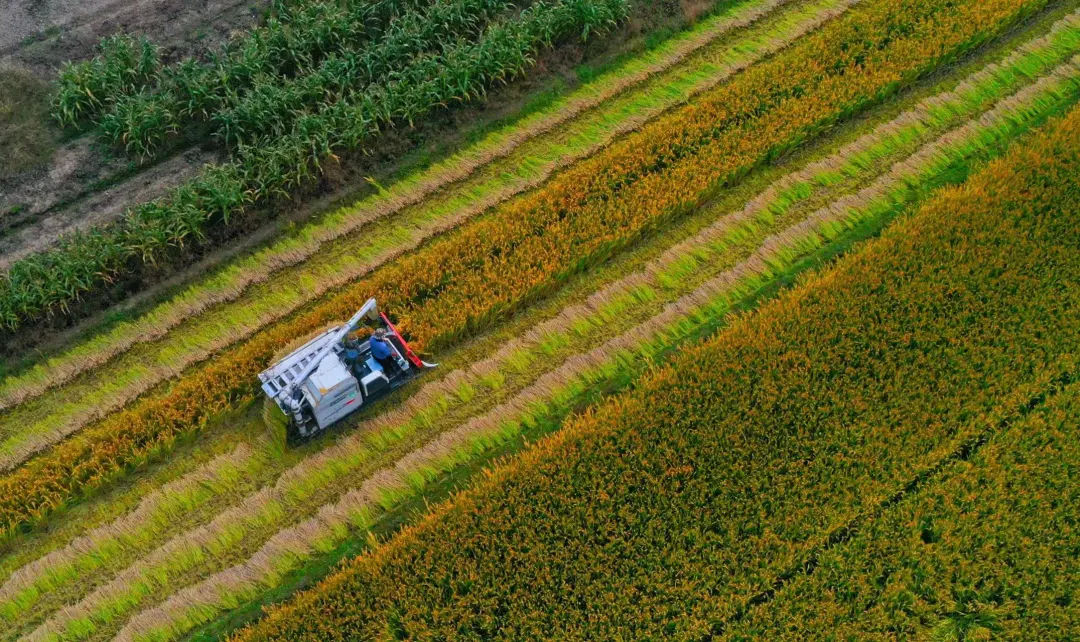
[[259, 298, 436, 438]]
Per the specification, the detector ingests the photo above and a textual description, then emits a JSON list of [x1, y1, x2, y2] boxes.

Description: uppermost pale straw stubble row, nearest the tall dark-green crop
[[0, 0, 803, 410]]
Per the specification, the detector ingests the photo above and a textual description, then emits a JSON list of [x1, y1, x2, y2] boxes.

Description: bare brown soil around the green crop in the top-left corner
[[0, 0, 269, 255]]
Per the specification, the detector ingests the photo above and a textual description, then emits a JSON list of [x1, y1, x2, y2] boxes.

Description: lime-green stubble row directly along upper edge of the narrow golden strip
[[0, 0, 859, 468]]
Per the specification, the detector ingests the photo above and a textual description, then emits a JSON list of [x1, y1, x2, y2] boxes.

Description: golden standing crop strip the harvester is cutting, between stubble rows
[[0, 0, 1043, 530]]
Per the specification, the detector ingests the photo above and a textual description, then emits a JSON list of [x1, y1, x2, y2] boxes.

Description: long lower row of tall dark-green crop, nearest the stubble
[[0, 0, 629, 329]]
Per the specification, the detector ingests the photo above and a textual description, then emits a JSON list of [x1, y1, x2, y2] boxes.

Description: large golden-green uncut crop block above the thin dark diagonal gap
[[234, 98, 1080, 642]]
